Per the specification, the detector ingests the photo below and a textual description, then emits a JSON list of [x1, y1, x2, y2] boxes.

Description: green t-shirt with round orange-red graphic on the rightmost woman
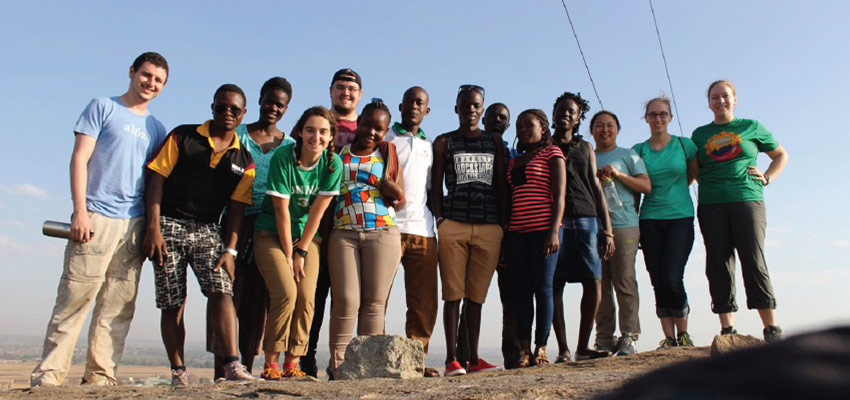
[[691, 118, 779, 204]]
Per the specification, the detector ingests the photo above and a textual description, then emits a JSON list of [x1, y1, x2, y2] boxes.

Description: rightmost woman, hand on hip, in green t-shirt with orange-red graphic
[[691, 80, 788, 342]]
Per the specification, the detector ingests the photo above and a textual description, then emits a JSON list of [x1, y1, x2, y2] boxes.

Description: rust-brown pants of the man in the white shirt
[[401, 233, 437, 354]]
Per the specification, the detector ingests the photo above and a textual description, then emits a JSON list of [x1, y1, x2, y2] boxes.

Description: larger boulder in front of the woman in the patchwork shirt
[[334, 335, 425, 379]]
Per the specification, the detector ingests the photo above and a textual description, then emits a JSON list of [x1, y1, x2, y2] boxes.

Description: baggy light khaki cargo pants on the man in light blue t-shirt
[[30, 211, 145, 386]]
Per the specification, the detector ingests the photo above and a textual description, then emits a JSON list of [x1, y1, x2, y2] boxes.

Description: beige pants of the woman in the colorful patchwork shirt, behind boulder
[[328, 226, 401, 371]]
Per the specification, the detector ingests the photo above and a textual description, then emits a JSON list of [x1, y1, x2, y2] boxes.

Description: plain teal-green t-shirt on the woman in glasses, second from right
[[632, 136, 697, 219]]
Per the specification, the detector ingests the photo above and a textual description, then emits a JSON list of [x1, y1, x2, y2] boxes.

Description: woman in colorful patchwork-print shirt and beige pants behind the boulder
[[328, 100, 404, 378]]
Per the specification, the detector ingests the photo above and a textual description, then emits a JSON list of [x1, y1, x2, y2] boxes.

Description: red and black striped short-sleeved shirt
[[507, 145, 564, 233]]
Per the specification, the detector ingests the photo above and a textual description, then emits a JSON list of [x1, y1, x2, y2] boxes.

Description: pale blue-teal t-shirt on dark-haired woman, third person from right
[[596, 147, 646, 228]]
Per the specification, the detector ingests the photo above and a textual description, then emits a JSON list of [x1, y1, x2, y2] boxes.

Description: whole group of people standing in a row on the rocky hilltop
[[31, 52, 788, 387]]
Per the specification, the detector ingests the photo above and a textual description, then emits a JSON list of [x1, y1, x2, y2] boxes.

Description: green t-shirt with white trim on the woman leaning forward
[[254, 144, 342, 238]]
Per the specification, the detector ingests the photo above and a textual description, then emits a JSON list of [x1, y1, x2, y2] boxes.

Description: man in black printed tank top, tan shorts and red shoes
[[431, 85, 505, 376]]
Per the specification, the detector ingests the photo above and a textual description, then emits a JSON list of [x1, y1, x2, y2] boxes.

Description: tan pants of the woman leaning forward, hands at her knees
[[254, 231, 319, 357]]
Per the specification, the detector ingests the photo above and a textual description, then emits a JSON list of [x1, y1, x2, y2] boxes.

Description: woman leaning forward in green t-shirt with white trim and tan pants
[[254, 107, 342, 380]]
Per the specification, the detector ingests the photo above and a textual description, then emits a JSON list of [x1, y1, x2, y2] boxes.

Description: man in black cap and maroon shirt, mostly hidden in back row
[[301, 68, 363, 377]]
